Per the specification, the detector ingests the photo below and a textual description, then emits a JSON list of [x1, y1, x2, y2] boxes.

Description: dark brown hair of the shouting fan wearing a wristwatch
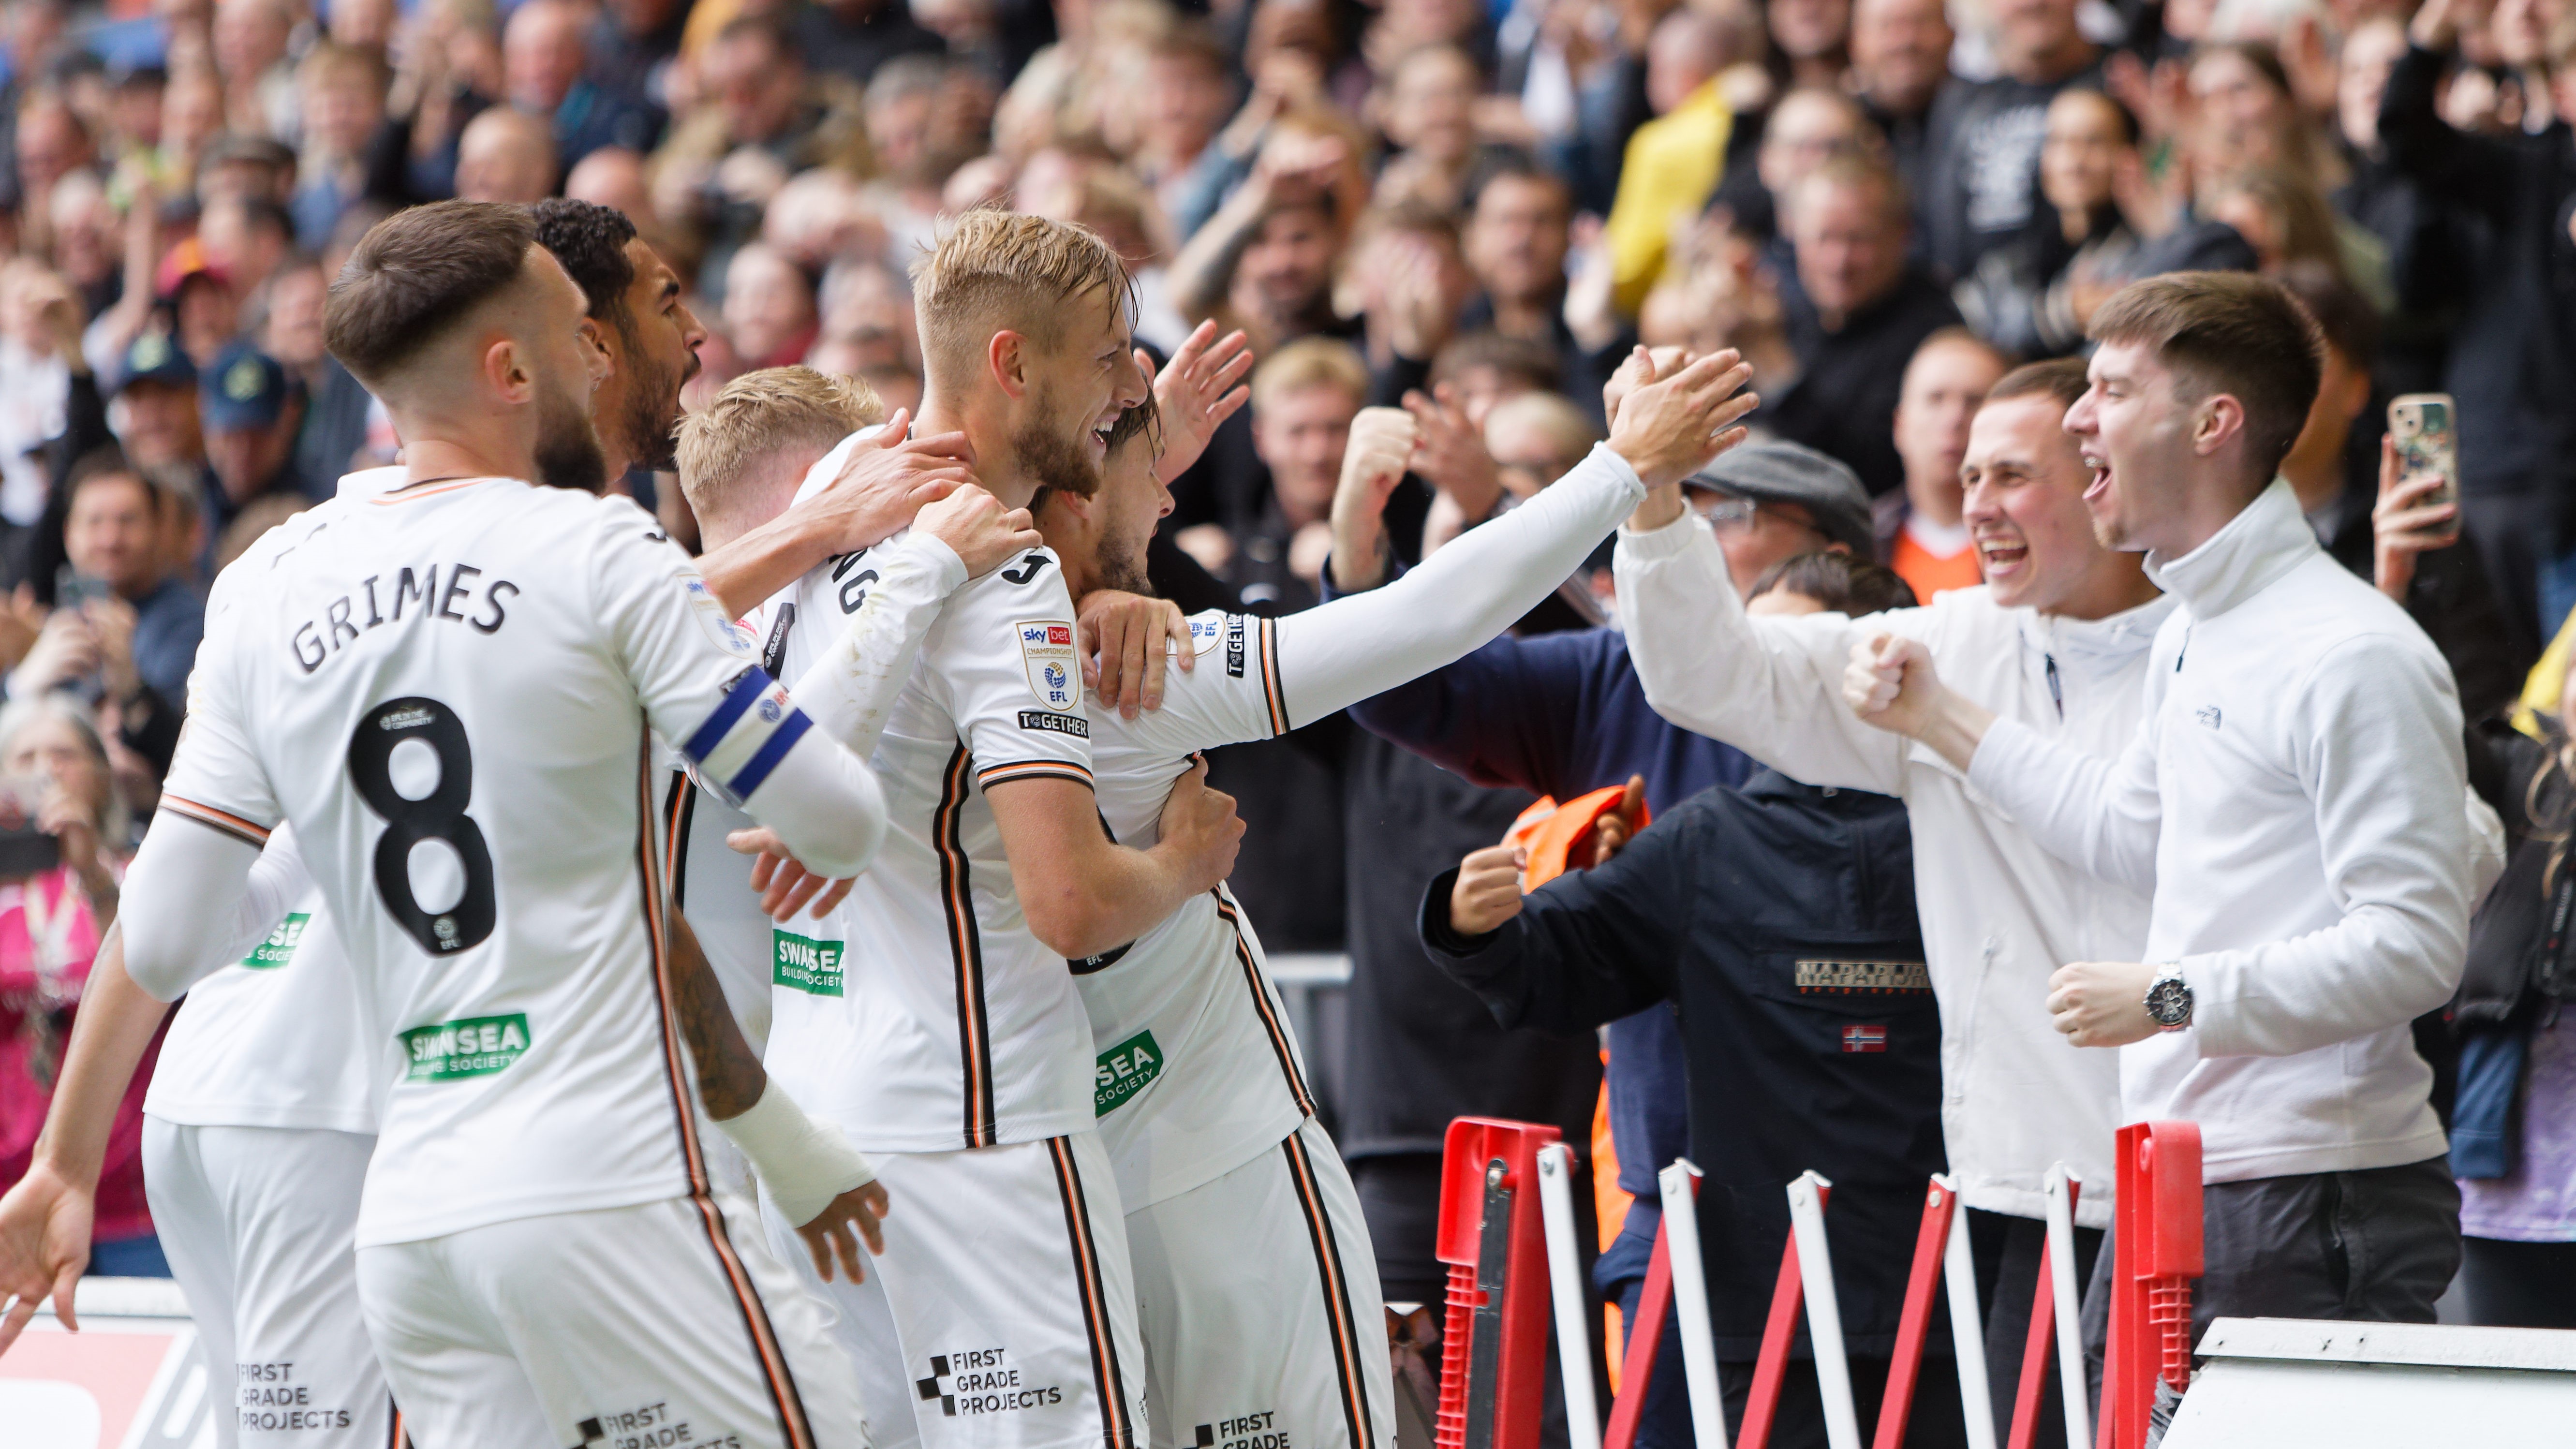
[[2092, 273, 2321, 479]]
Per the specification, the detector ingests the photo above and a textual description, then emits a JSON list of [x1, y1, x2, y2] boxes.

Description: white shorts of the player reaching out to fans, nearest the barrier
[[1128, 1117, 1396, 1449]]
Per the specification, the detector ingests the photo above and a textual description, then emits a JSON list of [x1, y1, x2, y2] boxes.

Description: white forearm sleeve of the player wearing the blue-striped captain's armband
[[773, 533, 966, 759]]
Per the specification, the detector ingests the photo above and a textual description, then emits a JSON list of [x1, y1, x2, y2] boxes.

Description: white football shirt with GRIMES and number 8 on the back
[[163, 479, 873, 1246]]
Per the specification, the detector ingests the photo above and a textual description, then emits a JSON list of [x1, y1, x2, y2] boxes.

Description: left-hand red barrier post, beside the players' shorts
[[1432, 1117, 1555, 1449]]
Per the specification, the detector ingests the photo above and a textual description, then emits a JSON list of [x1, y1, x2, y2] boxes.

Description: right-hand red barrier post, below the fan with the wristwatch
[[2094, 1122, 2203, 1449]]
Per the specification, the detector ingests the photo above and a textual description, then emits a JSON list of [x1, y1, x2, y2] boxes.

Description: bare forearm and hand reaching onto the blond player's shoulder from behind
[[698, 409, 974, 618]]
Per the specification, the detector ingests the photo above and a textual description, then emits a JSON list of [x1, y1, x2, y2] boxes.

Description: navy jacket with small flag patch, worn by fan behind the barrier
[[1422, 769, 1942, 1361]]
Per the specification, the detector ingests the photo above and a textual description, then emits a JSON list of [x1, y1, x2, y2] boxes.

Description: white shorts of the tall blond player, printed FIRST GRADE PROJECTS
[[762, 1132, 1146, 1449]]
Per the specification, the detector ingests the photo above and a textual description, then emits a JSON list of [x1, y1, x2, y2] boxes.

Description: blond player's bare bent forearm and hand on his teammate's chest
[[984, 762, 1244, 960]]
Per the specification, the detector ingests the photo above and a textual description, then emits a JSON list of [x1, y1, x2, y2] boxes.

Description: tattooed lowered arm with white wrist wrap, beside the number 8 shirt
[[670, 911, 886, 1282]]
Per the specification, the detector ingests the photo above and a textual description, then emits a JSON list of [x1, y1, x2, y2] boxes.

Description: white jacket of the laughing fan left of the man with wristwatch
[[1618, 515, 2174, 1227]]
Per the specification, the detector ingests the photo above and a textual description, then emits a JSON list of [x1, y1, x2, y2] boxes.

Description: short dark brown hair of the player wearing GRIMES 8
[[322, 201, 536, 389]]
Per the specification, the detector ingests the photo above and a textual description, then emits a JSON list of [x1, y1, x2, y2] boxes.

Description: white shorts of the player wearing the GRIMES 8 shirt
[[358, 1197, 868, 1449]]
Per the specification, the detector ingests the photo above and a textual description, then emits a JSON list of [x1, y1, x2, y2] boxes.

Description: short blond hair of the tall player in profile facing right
[[912, 206, 1131, 389]]
